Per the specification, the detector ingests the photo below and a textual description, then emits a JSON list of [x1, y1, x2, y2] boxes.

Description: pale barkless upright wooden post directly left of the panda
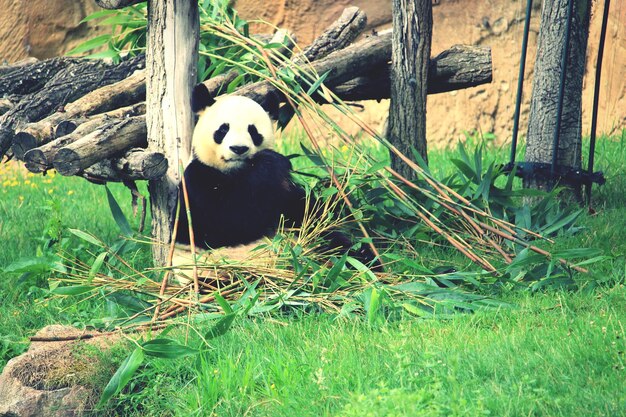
[[146, 0, 199, 265]]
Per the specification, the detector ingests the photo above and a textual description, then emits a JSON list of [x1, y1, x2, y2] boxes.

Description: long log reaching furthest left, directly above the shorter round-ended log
[[13, 70, 146, 159]]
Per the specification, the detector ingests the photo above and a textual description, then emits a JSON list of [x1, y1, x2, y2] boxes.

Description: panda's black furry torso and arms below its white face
[[176, 149, 306, 248]]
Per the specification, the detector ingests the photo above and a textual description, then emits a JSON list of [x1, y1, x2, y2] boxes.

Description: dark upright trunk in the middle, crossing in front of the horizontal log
[[387, 0, 433, 178]]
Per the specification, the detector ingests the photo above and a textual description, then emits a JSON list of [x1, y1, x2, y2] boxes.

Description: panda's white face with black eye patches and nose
[[192, 96, 274, 172]]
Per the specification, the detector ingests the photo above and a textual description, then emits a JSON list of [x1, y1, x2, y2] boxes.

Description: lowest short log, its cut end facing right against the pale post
[[79, 148, 167, 182]]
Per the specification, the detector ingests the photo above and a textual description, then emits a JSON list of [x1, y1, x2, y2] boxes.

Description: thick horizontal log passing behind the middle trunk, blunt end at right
[[332, 45, 492, 101]]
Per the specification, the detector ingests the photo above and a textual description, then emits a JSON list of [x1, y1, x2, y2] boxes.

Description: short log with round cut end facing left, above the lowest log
[[52, 116, 147, 175]]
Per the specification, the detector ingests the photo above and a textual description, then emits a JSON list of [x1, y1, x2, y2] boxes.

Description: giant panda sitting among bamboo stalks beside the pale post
[[168, 84, 379, 282]]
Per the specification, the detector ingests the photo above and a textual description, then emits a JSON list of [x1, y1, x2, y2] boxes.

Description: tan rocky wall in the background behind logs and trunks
[[0, 0, 626, 145]]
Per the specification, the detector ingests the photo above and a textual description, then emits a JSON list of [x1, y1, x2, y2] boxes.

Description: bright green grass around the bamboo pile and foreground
[[0, 133, 626, 417]]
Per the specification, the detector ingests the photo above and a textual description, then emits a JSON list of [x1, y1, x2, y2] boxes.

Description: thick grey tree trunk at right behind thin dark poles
[[524, 0, 591, 195]]
